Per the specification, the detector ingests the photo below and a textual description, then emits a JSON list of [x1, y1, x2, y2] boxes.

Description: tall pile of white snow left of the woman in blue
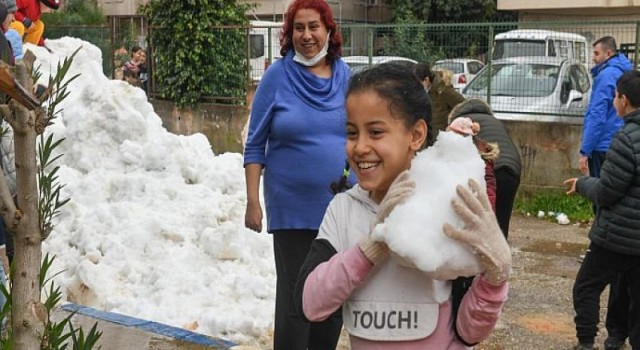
[[25, 38, 276, 343]]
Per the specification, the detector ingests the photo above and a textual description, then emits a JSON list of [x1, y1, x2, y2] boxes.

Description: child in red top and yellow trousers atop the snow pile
[[10, 0, 60, 45]]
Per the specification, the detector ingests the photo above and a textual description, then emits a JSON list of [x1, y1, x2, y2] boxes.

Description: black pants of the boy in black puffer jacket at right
[[573, 243, 640, 349]]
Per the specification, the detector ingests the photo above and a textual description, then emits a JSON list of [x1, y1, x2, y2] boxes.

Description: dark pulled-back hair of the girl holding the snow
[[347, 63, 435, 146]]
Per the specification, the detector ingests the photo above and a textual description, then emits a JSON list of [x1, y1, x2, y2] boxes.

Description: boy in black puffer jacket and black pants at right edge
[[565, 70, 640, 350]]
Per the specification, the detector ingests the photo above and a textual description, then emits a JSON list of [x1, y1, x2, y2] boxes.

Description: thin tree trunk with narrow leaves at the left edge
[[0, 51, 77, 350]]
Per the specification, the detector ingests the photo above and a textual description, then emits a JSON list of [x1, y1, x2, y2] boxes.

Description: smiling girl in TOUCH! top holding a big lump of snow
[[295, 64, 511, 350]]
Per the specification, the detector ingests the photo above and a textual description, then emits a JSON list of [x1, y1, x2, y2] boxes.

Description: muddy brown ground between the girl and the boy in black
[[477, 216, 607, 350]]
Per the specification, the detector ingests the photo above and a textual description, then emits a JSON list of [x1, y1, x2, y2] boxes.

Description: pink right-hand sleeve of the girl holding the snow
[[456, 275, 509, 344]]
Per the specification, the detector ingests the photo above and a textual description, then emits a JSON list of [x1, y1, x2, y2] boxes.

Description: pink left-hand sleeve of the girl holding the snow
[[302, 245, 373, 322]]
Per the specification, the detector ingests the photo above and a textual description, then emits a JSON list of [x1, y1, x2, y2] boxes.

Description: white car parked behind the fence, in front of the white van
[[462, 56, 592, 123]]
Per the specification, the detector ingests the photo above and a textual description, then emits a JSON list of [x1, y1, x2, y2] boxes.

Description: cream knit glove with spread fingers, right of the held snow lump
[[443, 179, 511, 285]]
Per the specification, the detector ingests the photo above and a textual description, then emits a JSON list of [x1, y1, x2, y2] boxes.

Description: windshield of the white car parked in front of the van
[[464, 63, 560, 97]]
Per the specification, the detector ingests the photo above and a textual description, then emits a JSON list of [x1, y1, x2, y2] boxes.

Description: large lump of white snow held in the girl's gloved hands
[[372, 132, 486, 279]]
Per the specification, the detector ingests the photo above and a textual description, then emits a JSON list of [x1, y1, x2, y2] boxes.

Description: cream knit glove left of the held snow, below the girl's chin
[[358, 170, 416, 266]]
